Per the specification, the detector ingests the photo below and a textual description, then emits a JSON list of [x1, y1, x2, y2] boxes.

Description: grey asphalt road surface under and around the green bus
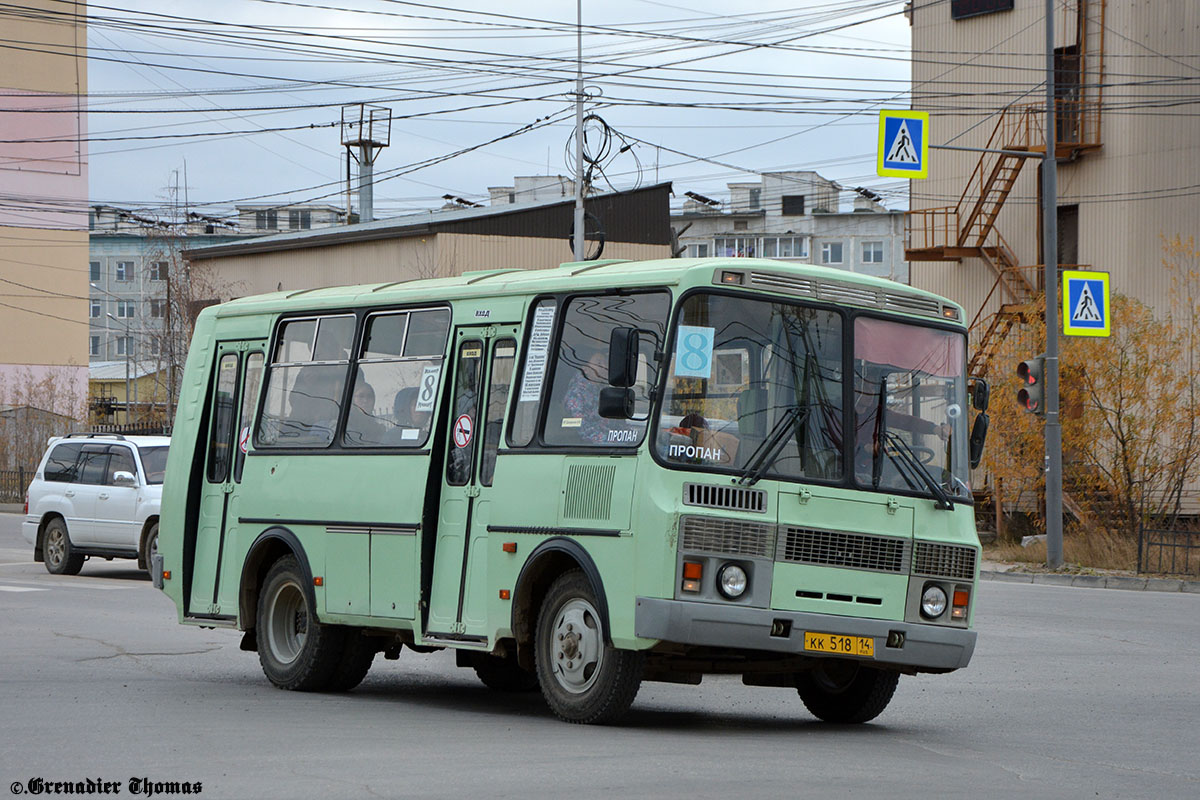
[[0, 515, 1200, 800]]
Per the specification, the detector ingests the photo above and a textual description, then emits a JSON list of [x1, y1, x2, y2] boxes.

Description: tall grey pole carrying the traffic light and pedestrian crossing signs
[[1042, 0, 1062, 569]]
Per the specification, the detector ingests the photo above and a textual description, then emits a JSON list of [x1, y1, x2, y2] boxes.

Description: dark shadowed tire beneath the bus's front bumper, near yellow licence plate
[[796, 658, 900, 724]]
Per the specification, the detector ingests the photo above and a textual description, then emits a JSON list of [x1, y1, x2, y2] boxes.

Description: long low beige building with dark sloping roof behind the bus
[[185, 184, 671, 299]]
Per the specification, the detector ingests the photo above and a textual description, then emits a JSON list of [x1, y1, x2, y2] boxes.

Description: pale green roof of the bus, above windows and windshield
[[211, 258, 964, 323]]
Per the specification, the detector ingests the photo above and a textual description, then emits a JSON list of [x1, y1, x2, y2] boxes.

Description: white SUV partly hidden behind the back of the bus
[[22, 433, 170, 575]]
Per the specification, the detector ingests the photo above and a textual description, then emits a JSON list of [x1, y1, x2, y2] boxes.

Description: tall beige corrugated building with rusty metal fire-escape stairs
[[908, 0, 1200, 374]]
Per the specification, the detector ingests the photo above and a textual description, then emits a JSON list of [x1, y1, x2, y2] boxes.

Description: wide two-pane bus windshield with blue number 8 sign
[[655, 293, 968, 499]]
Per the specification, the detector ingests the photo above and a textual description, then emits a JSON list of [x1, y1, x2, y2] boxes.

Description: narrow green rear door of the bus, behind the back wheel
[[187, 341, 266, 618]]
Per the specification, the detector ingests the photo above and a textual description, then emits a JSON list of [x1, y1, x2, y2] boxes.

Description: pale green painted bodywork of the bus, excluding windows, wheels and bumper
[[158, 259, 978, 662]]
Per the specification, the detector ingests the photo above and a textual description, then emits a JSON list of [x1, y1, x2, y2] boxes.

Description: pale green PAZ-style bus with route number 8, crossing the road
[[154, 258, 988, 723]]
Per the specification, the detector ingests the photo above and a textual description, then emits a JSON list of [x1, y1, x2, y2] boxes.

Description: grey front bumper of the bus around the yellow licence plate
[[634, 597, 976, 670]]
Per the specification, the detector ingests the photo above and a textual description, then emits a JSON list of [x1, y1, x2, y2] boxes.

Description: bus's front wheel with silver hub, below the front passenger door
[[534, 570, 644, 724]]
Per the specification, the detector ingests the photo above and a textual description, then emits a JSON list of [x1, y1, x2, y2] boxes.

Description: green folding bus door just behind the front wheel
[[426, 326, 517, 639]]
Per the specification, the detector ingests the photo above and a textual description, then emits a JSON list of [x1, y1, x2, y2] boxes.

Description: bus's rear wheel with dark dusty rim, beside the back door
[[256, 555, 346, 692]]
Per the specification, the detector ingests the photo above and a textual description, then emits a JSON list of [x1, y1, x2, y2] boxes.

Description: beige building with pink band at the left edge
[[0, 0, 88, 416]]
